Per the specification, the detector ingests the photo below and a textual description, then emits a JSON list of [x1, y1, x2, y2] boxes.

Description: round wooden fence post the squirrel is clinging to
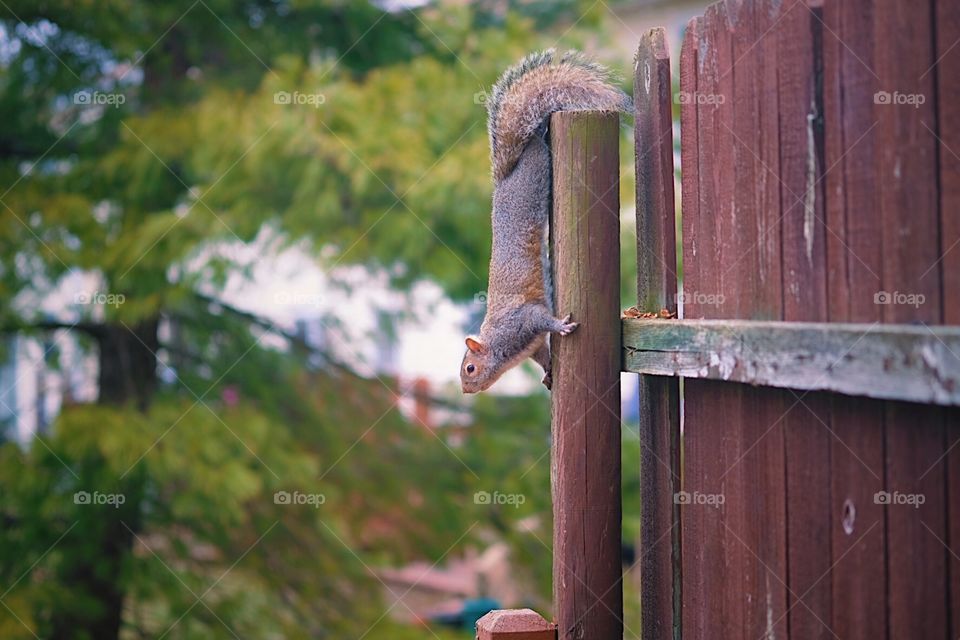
[[550, 111, 623, 640]]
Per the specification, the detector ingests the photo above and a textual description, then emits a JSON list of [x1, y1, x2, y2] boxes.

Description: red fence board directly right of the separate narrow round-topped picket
[[680, 3, 741, 638]]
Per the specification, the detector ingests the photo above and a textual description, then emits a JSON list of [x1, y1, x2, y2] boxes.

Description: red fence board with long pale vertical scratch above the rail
[[777, 2, 831, 638]]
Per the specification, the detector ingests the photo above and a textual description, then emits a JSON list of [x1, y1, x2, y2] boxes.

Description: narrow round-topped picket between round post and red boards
[[634, 29, 681, 640]]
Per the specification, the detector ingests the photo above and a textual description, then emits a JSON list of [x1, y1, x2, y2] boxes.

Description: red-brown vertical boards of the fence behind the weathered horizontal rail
[[637, 0, 960, 639]]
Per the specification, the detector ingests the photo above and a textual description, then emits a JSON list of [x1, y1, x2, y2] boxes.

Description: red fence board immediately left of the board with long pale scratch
[[722, 0, 788, 638]]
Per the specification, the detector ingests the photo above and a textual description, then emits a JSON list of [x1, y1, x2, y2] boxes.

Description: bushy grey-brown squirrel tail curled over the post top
[[487, 49, 631, 180]]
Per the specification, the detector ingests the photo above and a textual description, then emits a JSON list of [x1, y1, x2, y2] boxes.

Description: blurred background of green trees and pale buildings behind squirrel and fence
[[0, 0, 706, 640]]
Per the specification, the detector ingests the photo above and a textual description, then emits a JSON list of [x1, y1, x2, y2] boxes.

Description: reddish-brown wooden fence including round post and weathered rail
[[480, 0, 960, 640]]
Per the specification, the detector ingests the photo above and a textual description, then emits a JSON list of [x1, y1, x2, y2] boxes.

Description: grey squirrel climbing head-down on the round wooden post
[[460, 49, 631, 393]]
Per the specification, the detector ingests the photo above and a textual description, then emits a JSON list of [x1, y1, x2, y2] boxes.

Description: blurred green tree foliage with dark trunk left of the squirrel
[[0, 0, 628, 639]]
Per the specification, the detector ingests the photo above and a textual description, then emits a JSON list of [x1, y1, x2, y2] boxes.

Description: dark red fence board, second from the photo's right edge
[[873, 2, 947, 637]]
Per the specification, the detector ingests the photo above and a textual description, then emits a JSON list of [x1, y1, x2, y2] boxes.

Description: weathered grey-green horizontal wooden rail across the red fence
[[623, 319, 960, 406]]
